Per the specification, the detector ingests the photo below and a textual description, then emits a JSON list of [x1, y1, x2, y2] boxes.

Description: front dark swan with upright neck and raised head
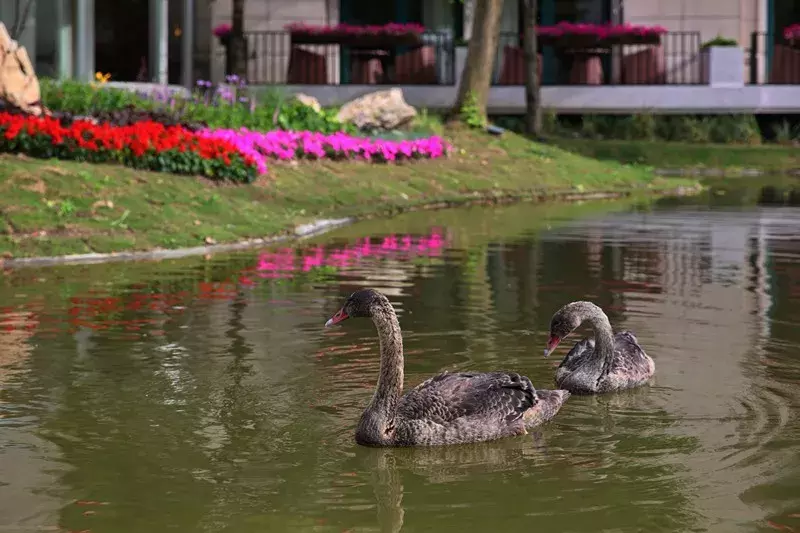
[[325, 289, 570, 446]]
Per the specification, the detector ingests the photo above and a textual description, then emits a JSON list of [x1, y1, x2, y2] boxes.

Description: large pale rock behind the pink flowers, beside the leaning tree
[[338, 88, 417, 130]]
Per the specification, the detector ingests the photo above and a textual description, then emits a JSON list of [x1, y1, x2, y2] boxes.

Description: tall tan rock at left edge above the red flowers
[[0, 22, 45, 115]]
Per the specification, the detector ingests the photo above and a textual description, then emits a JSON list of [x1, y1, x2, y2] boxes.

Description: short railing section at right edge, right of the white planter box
[[748, 32, 800, 85]]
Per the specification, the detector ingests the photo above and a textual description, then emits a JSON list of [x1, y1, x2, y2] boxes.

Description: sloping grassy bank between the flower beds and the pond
[[0, 125, 695, 257]]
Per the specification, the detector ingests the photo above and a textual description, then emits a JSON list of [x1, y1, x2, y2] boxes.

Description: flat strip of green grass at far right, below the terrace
[[551, 138, 800, 173]]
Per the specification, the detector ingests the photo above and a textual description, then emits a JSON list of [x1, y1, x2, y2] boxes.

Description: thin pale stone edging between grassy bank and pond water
[[0, 184, 703, 268]]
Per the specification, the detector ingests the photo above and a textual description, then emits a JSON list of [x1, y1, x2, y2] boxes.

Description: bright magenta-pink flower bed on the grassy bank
[[198, 128, 452, 173]]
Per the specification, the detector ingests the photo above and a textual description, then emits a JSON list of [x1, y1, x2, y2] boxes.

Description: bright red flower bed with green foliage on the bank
[[0, 112, 257, 182]]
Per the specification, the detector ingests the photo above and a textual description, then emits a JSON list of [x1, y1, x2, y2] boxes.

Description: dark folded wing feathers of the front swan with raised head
[[398, 372, 537, 424]]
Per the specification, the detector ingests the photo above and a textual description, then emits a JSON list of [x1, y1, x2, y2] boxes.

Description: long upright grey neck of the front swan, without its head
[[368, 306, 404, 417]]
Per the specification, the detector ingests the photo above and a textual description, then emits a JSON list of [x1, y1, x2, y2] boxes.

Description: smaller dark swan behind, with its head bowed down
[[544, 302, 656, 394]]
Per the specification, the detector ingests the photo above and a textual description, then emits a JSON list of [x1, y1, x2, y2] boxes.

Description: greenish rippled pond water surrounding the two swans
[[0, 182, 800, 533]]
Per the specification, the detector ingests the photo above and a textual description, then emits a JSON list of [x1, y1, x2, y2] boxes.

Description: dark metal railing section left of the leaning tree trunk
[[245, 31, 456, 85]]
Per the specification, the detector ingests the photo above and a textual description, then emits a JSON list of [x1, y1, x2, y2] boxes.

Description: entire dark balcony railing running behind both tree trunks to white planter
[[239, 31, 703, 85]]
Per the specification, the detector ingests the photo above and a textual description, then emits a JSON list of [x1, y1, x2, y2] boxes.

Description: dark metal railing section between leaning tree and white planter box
[[492, 32, 705, 85]]
